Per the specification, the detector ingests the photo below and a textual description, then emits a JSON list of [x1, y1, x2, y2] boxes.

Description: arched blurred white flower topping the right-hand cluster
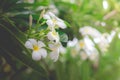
[[79, 26, 101, 38]]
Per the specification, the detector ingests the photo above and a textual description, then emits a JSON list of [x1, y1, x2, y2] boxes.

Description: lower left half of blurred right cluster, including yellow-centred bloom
[[68, 36, 98, 61]]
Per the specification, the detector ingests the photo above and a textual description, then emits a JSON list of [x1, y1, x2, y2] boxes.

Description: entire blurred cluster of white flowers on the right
[[63, 26, 115, 63]]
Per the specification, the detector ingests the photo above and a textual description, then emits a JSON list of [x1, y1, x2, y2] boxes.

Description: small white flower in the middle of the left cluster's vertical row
[[47, 30, 60, 43]]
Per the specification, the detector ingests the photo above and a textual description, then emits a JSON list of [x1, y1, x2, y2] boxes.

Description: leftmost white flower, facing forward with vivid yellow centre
[[25, 39, 47, 60]]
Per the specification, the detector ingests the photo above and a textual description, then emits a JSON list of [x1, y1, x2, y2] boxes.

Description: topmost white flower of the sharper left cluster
[[43, 12, 66, 29]]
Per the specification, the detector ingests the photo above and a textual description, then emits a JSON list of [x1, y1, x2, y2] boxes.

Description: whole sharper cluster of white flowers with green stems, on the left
[[25, 12, 66, 61]]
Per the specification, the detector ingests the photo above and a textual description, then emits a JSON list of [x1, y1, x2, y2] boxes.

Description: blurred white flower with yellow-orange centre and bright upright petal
[[76, 36, 99, 61]]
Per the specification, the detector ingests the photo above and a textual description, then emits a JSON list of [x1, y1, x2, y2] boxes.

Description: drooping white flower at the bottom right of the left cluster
[[49, 43, 61, 62]]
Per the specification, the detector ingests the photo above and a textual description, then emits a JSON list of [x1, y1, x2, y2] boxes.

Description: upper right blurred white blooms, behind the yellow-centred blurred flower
[[79, 26, 113, 53]]
